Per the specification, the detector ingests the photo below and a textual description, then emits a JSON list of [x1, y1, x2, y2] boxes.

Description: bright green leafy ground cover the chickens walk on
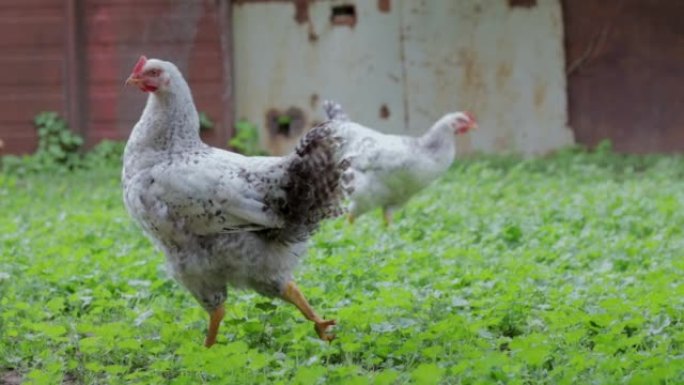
[[0, 152, 684, 384]]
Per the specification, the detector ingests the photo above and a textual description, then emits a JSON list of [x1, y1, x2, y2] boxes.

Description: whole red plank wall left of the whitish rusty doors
[[0, 0, 233, 154]]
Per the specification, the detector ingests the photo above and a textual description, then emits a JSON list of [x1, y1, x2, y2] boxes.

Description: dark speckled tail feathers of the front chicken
[[264, 121, 349, 241]]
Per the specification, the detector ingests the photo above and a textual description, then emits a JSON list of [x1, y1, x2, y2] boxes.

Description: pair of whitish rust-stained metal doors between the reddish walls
[[233, 0, 573, 154]]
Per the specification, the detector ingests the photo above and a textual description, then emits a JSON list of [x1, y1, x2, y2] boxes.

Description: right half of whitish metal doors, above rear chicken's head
[[401, 0, 573, 154]]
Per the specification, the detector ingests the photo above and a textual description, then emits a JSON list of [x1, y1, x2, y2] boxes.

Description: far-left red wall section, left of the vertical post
[[0, 0, 67, 153]]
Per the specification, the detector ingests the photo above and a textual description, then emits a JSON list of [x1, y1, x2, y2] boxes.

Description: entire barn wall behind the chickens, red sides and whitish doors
[[0, 0, 684, 154]]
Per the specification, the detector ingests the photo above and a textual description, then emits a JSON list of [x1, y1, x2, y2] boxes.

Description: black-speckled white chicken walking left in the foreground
[[122, 56, 348, 347]]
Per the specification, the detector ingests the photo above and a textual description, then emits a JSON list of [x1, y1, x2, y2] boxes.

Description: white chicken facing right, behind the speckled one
[[323, 100, 477, 225]]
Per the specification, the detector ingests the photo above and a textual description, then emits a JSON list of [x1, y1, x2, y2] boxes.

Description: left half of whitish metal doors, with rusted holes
[[233, 0, 404, 154]]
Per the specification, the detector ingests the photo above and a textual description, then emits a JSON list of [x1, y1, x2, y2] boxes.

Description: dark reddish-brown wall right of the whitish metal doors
[[563, 0, 684, 153]]
